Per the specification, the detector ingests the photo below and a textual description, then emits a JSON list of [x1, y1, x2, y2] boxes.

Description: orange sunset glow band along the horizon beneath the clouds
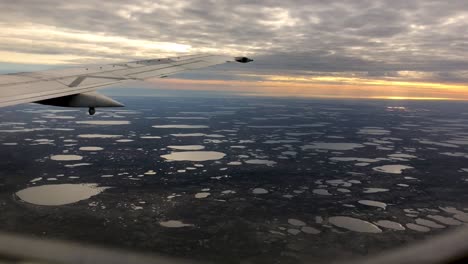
[[148, 76, 468, 100]]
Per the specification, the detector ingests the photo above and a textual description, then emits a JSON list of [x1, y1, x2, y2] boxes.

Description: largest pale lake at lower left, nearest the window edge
[[16, 183, 108, 206]]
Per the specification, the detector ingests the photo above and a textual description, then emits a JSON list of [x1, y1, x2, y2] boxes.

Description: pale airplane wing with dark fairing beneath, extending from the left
[[0, 54, 252, 114]]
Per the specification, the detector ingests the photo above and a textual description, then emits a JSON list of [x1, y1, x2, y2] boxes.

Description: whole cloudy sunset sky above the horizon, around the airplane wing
[[0, 0, 468, 100]]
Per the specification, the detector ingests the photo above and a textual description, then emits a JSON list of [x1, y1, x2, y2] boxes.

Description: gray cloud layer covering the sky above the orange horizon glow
[[0, 0, 468, 82]]
